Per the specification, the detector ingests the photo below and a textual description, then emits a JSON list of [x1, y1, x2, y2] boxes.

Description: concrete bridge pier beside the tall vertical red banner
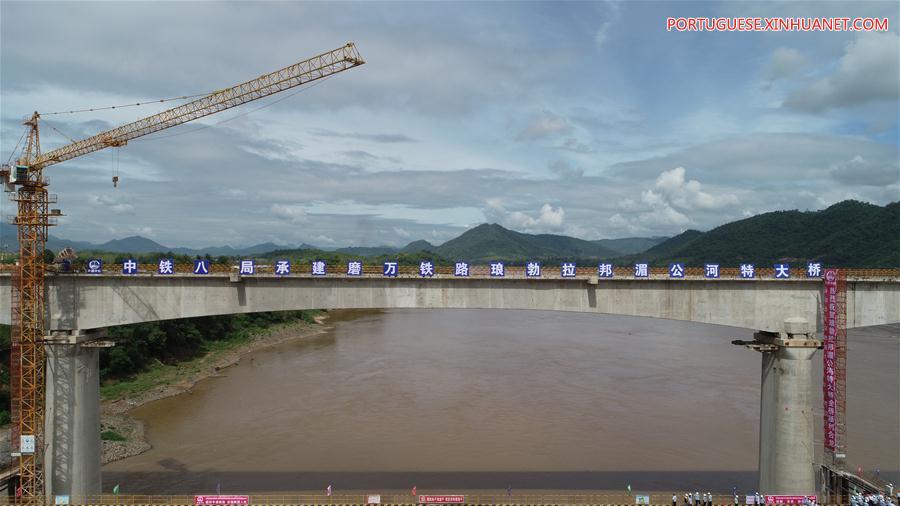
[[735, 318, 822, 495]]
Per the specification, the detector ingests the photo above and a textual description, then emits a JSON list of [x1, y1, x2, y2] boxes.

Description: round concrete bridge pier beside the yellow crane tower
[[44, 332, 108, 499]]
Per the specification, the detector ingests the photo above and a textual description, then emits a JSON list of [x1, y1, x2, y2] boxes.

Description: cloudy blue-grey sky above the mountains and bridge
[[0, 0, 900, 247]]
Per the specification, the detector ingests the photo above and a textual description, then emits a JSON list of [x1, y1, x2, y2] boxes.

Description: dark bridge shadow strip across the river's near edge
[[103, 468, 758, 494]]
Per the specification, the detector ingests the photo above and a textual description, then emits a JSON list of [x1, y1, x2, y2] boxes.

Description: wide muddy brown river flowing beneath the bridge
[[103, 310, 900, 494]]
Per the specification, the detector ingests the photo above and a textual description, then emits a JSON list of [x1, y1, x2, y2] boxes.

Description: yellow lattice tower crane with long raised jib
[[0, 42, 365, 503]]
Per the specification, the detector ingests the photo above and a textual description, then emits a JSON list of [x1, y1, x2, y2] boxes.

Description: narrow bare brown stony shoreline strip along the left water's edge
[[100, 311, 345, 465]]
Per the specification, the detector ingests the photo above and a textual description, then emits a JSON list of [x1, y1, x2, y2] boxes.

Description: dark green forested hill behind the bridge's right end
[[629, 200, 900, 267]]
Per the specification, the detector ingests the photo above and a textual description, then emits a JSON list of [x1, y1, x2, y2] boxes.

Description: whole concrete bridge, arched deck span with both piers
[[0, 268, 900, 496]]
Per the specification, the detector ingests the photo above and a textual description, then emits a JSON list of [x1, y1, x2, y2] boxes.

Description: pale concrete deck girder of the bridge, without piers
[[0, 275, 900, 332]]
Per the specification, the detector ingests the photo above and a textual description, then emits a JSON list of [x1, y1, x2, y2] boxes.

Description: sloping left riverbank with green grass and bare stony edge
[[100, 312, 338, 464]]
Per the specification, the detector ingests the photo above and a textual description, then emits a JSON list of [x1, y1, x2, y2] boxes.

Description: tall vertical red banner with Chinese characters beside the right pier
[[822, 269, 838, 451]]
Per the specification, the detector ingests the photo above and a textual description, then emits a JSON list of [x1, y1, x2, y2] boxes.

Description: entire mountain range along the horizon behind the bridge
[[0, 200, 900, 267]]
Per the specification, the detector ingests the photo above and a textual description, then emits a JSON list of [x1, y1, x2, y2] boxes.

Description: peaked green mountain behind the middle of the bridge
[[433, 223, 619, 262]]
